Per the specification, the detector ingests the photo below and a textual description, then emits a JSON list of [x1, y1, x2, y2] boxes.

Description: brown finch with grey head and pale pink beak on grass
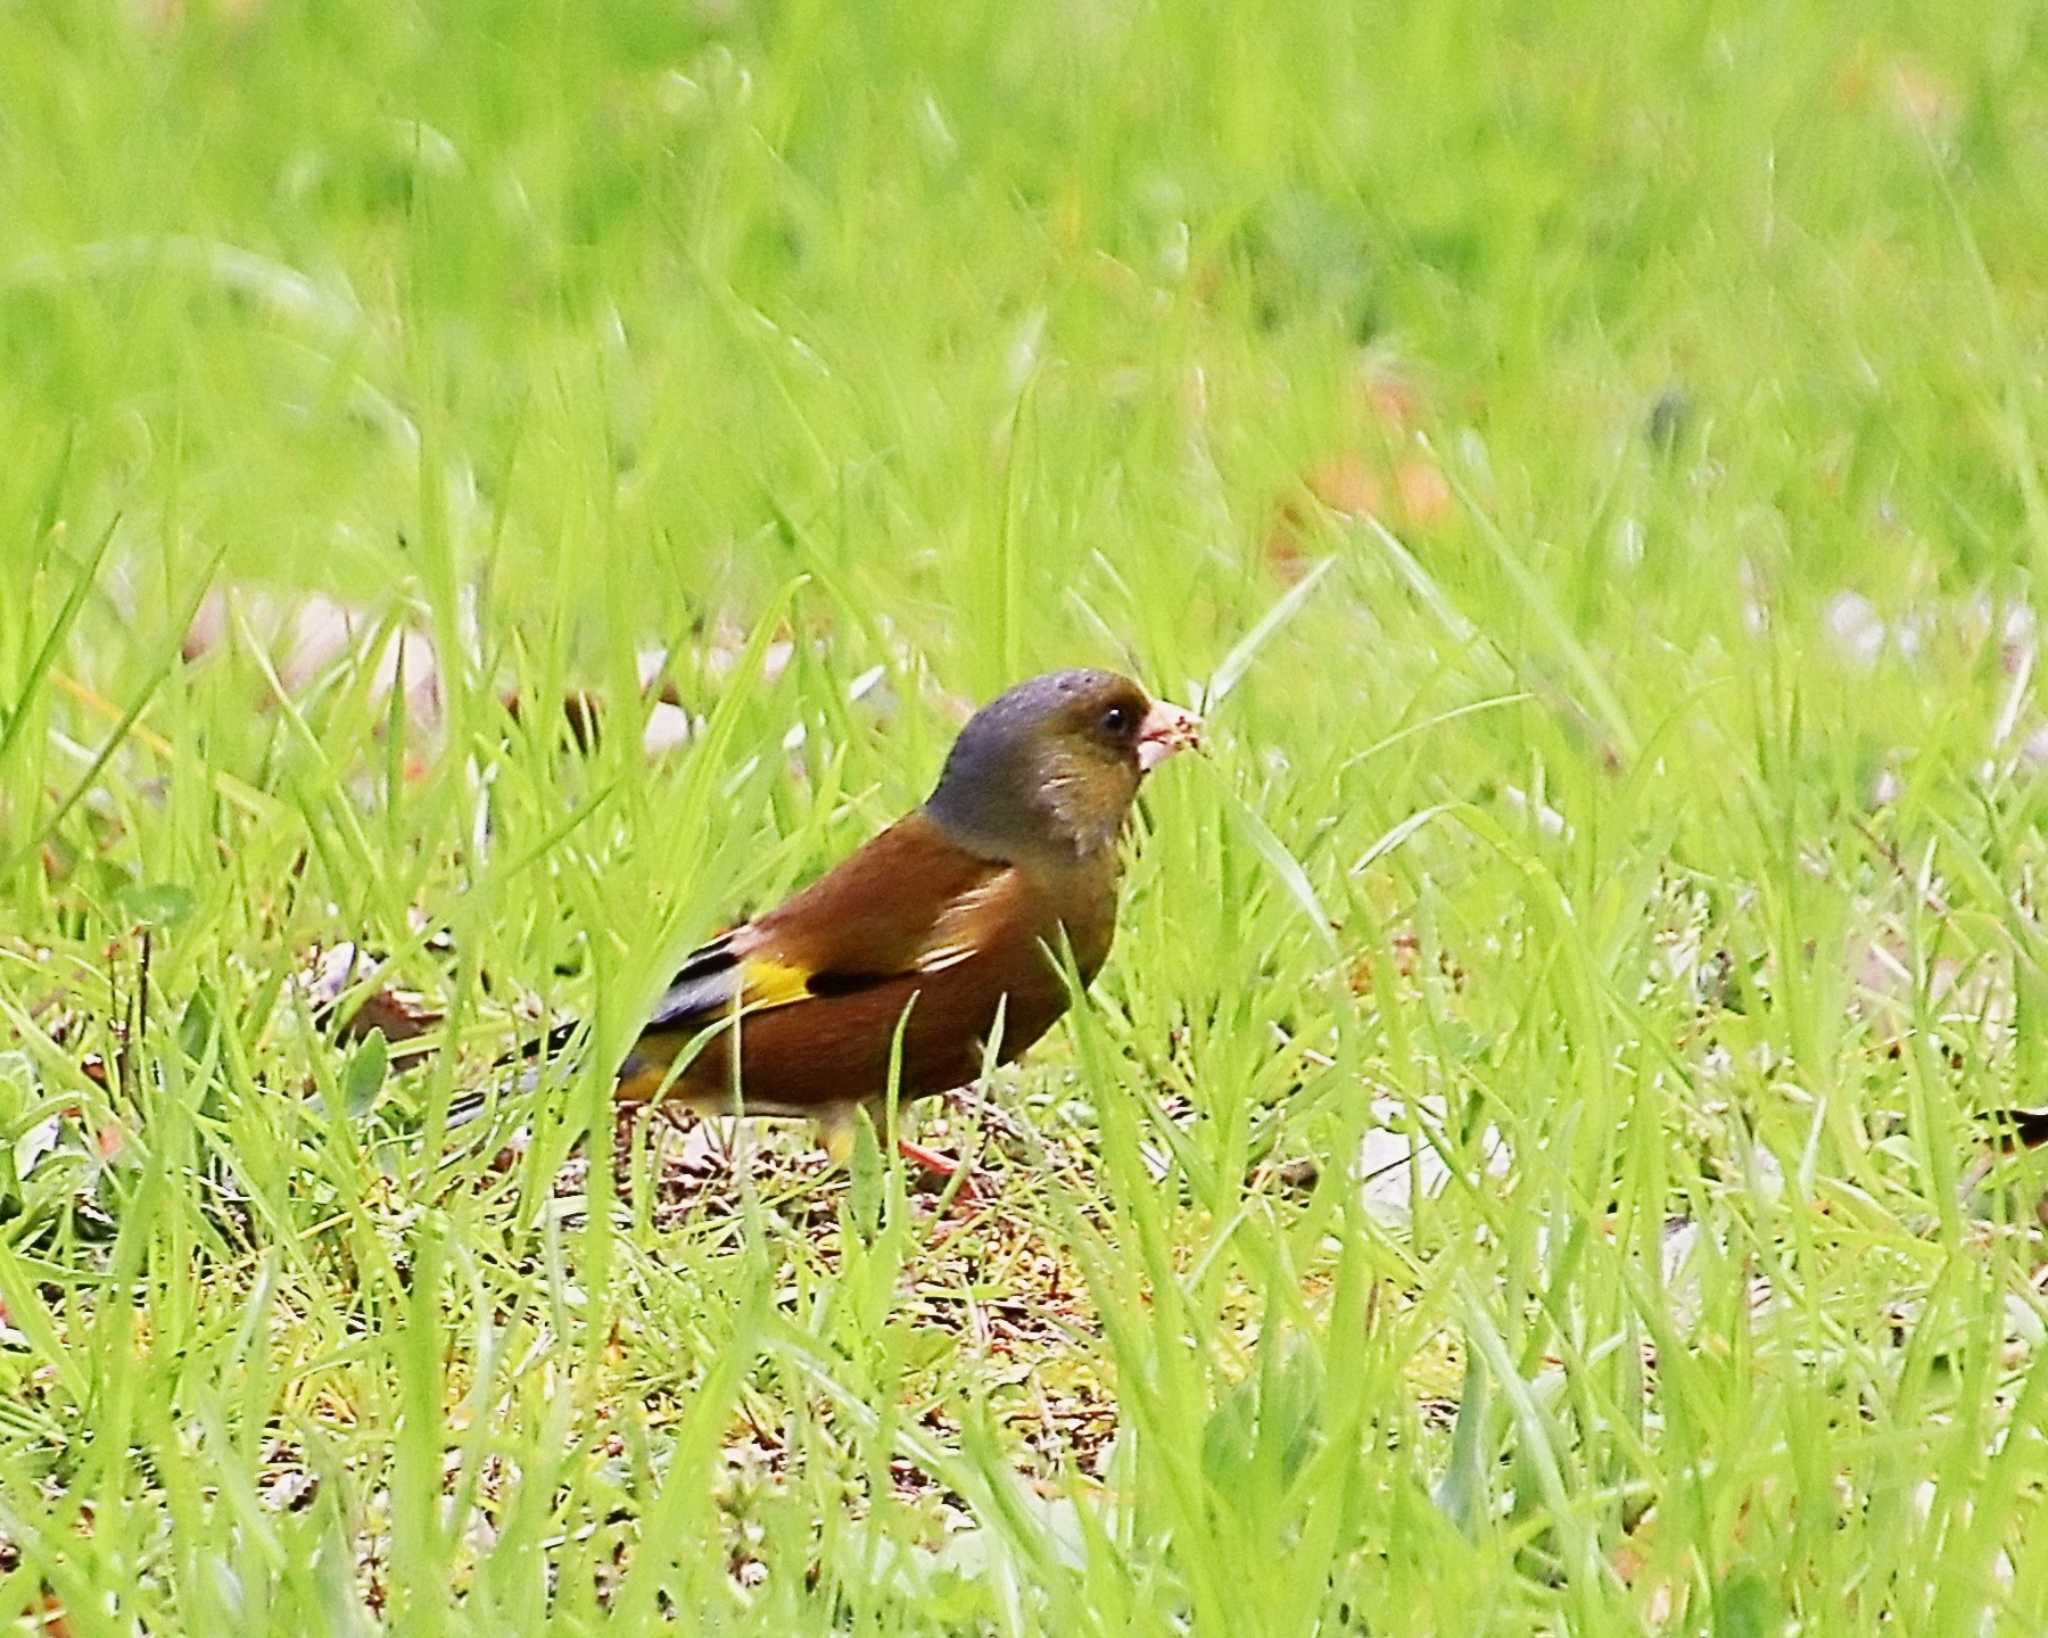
[[464, 670, 1202, 1175]]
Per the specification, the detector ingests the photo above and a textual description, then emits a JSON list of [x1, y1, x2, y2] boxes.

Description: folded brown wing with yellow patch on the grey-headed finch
[[647, 813, 1022, 1030]]
